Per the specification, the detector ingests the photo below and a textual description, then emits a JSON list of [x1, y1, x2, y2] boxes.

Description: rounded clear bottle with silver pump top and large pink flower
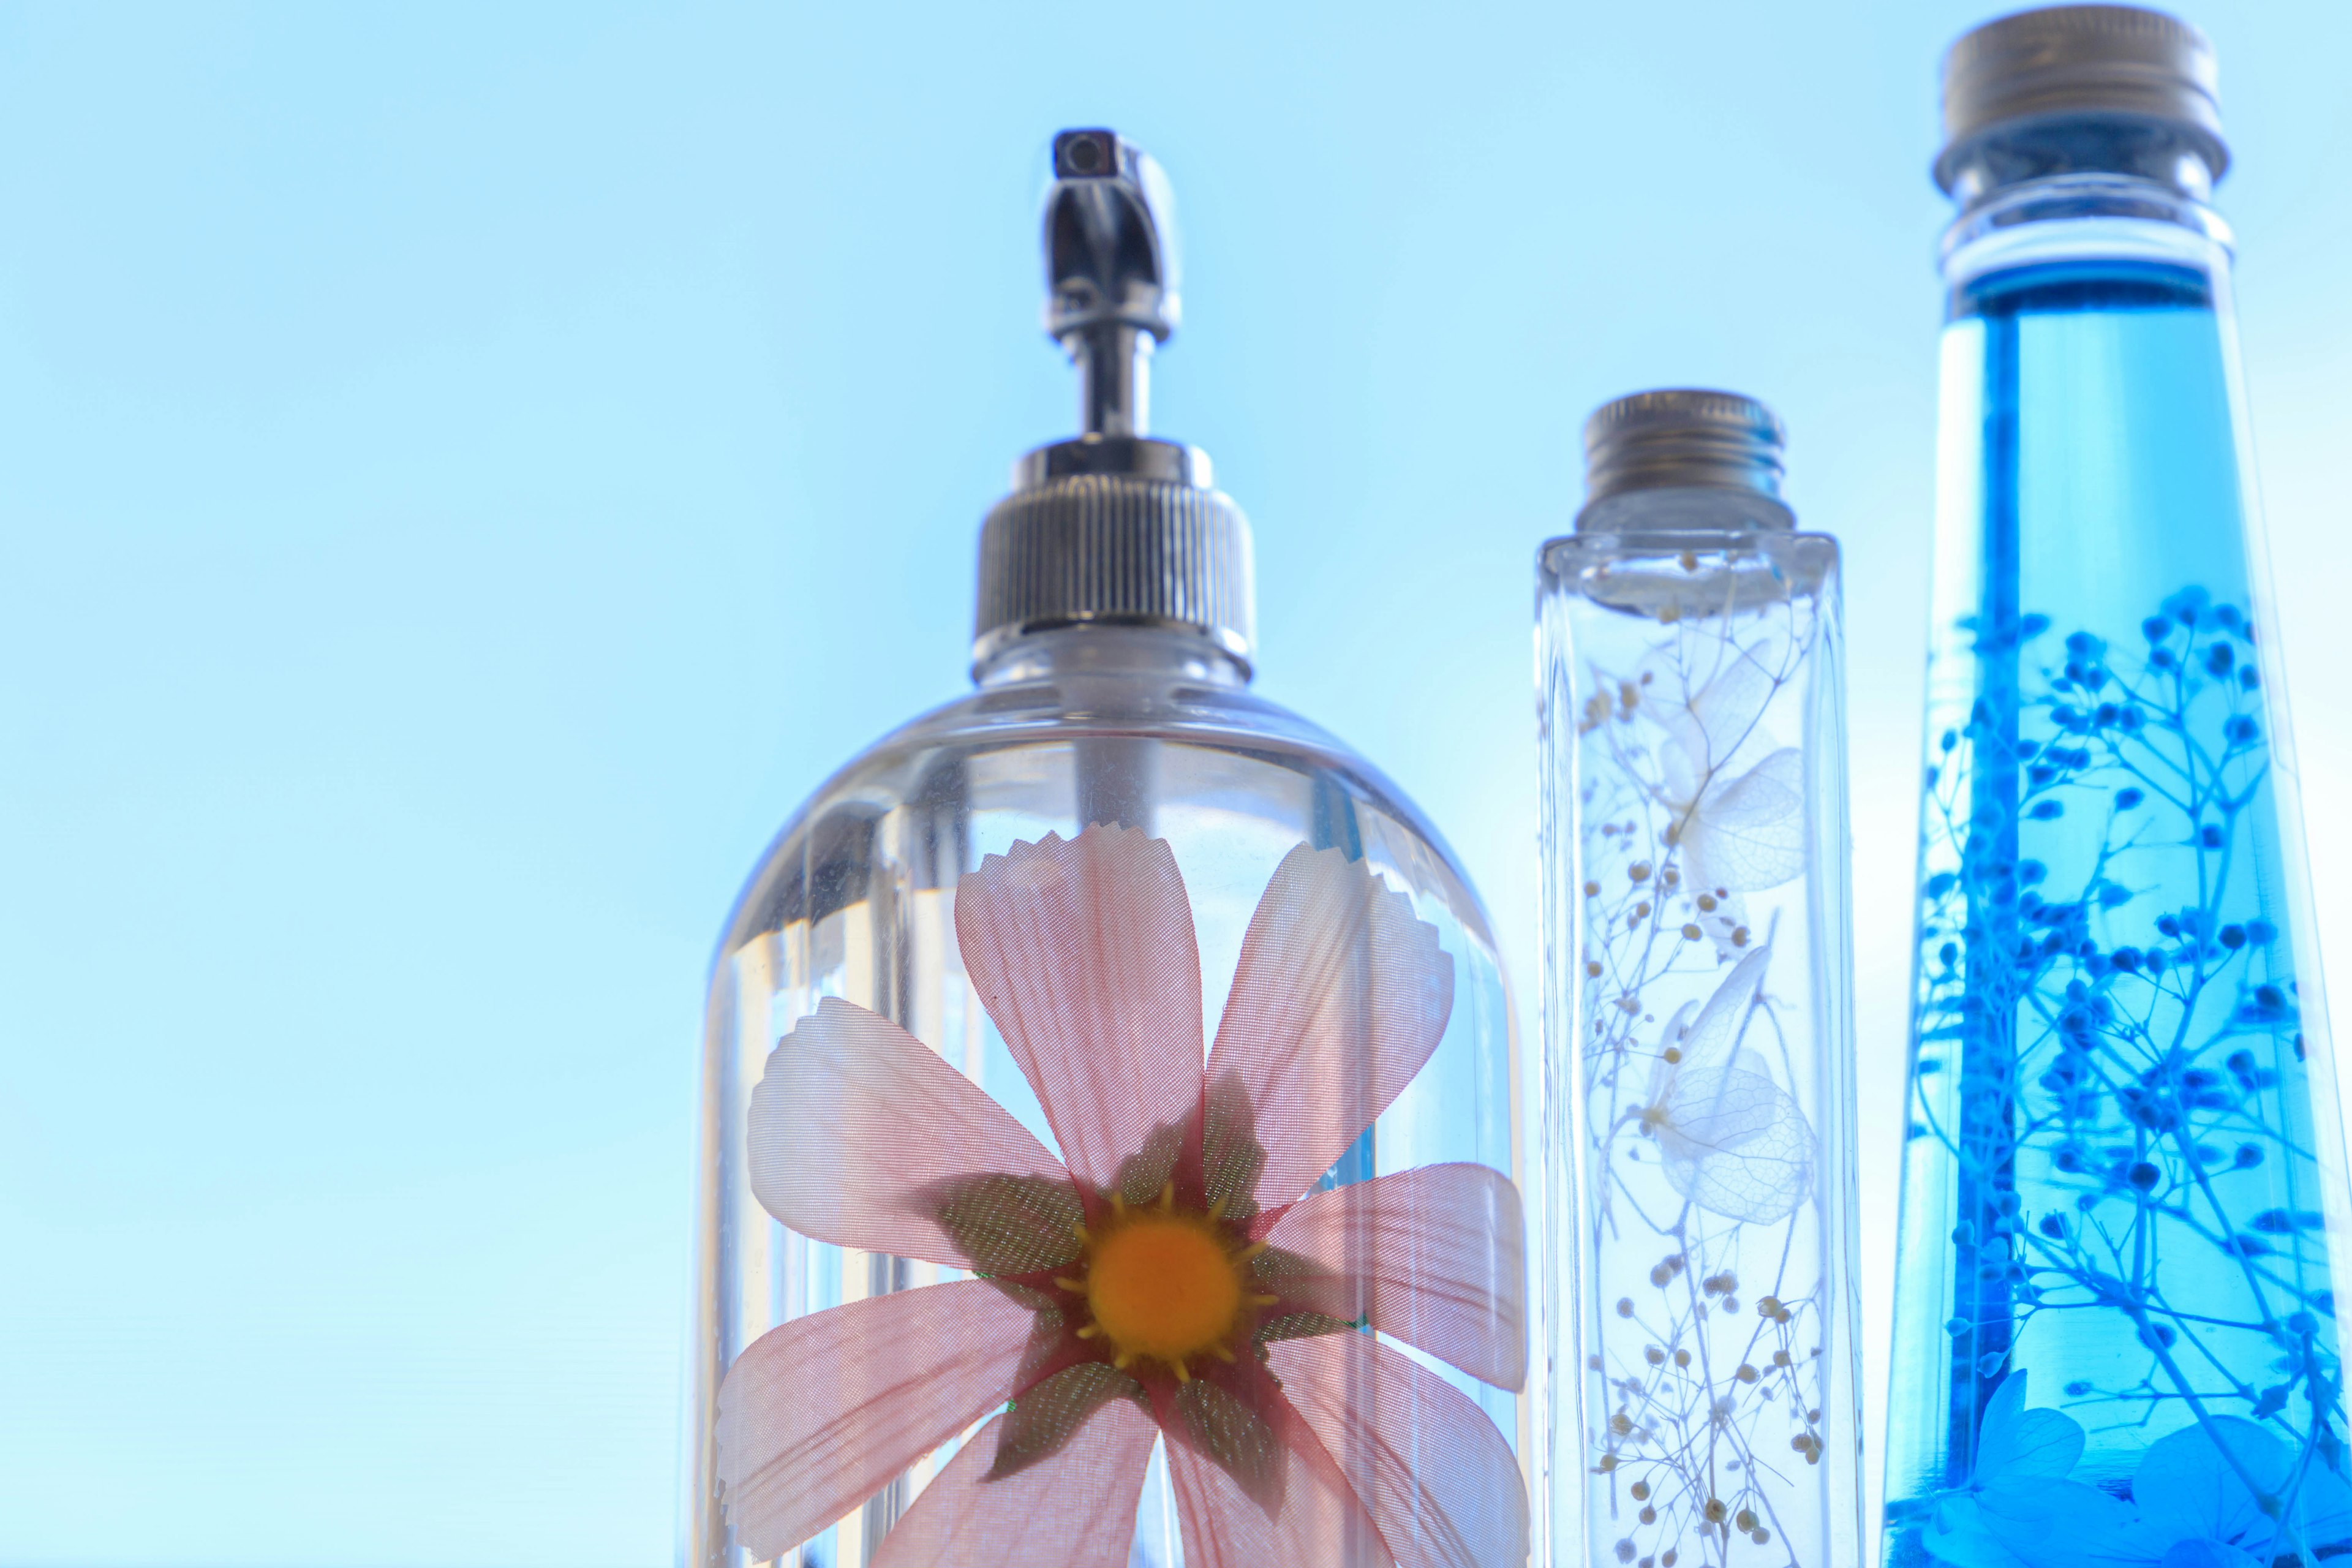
[[682, 132, 1526, 1568]]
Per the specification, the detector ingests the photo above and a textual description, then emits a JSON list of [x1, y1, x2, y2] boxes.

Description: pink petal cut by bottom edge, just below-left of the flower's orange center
[[875, 1399, 1159, 1568]]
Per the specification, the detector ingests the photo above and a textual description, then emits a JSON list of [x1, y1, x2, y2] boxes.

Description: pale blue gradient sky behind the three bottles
[[0, 0, 2352, 1568]]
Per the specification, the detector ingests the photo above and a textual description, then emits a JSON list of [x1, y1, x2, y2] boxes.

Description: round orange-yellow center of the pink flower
[[1056, 1189, 1277, 1382]]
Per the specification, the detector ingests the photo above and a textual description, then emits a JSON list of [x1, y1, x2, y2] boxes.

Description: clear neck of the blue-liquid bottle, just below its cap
[[1943, 165, 2232, 292]]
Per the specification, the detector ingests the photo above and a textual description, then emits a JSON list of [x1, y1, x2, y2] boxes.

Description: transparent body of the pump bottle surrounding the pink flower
[[687, 628, 1521, 1568]]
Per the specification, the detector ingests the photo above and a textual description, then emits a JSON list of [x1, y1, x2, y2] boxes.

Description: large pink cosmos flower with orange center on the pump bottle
[[717, 827, 1526, 1568]]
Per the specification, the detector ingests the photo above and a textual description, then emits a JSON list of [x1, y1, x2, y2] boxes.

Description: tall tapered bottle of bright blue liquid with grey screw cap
[[1884, 7, 2352, 1568]]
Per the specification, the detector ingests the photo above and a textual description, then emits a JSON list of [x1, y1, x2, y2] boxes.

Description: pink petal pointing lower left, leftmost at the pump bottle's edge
[[717, 1279, 1037, 1559]]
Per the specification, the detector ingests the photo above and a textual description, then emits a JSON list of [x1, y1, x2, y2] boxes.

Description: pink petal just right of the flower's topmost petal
[[1207, 844, 1453, 1206]]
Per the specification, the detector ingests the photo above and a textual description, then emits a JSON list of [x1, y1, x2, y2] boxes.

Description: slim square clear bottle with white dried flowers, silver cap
[[1534, 393, 1860, 1568]]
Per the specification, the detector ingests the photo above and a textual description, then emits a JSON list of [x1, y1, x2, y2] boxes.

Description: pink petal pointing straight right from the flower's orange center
[[1265, 1164, 1526, 1389]]
